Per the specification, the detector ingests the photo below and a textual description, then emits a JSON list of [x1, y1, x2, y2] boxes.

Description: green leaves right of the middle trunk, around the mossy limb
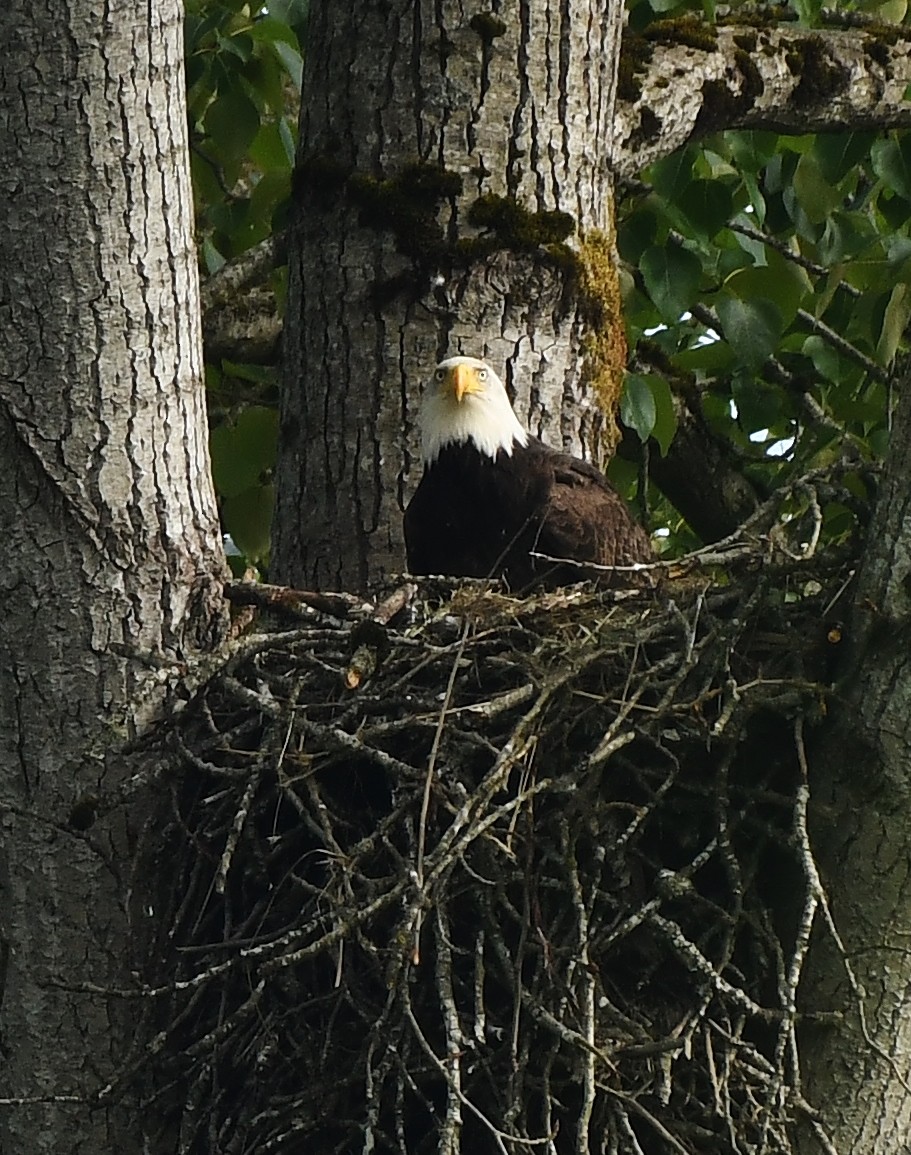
[[619, 0, 911, 549]]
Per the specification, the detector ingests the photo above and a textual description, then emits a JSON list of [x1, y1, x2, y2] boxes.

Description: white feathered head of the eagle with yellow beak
[[420, 357, 529, 465]]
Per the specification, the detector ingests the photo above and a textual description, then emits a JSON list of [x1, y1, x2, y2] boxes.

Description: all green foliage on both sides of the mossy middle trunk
[[187, 0, 911, 561]]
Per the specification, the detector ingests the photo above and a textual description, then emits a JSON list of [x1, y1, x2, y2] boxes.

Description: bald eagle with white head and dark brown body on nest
[[405, 357, 655, 593]]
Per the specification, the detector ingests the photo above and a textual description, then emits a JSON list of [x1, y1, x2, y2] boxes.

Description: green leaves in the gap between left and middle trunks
[[186, 0, 306, 562]]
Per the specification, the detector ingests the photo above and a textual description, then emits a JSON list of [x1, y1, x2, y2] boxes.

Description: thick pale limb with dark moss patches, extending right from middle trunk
[[613, 20, 911, 176]]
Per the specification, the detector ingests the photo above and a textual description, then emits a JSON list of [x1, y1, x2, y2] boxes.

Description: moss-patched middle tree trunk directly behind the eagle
[[272, 0, 626, 589]]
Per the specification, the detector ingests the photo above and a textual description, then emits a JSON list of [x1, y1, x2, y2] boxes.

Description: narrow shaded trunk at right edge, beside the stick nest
[[800, 371, 911, 1155]]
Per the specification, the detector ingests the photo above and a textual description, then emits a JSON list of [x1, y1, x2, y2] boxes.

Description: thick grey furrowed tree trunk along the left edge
[[0, 0, 223, 1153]]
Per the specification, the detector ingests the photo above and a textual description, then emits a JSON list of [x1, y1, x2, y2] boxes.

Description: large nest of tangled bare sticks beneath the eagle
[[136, 539, 846, 1155]]
